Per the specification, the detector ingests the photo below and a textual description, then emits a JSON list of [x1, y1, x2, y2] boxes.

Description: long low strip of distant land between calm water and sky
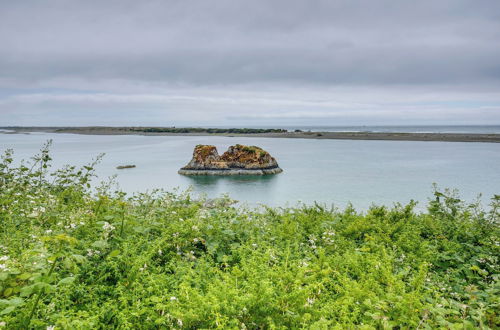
[[0, 126, 500, 143]]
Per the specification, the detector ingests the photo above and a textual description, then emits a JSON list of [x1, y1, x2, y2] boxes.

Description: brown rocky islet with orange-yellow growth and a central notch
[[179, 144, 283, 175]]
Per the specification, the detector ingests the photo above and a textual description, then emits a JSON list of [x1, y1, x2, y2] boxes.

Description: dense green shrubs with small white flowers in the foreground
[[0, 148, 500, 329]]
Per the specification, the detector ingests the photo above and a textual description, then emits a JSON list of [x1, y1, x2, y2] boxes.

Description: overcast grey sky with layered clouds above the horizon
[[0, 0, 500, 127]]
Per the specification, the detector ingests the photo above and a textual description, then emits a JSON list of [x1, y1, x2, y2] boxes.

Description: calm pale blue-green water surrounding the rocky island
[[0, 133, 500, 209]]
